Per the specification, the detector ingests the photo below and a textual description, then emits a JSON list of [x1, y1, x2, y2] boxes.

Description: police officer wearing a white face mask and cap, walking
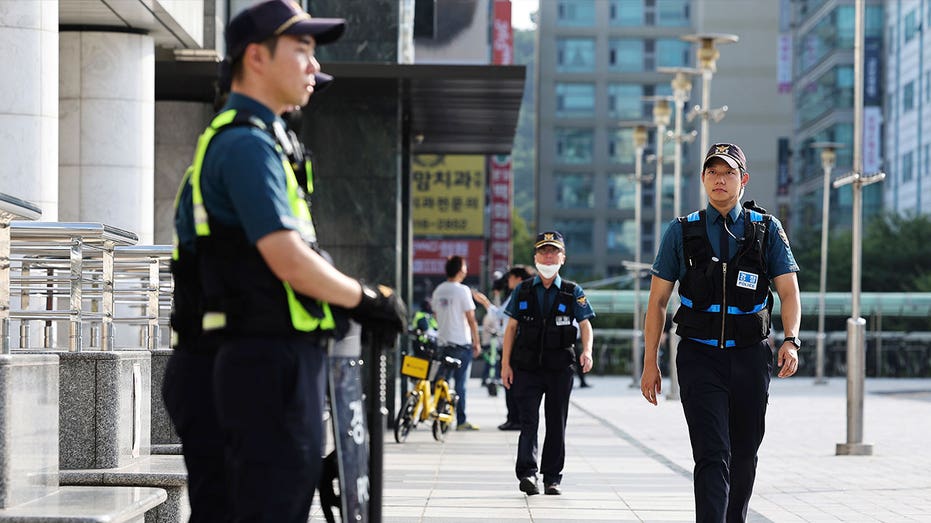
[[501, 231, 595, 496]]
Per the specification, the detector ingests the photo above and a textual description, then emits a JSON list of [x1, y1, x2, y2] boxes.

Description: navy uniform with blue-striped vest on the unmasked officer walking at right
[[652, 202, 799, 522]]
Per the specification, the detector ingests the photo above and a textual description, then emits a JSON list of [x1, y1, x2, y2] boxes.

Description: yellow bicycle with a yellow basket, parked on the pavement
[[394, 337, 462, 443]]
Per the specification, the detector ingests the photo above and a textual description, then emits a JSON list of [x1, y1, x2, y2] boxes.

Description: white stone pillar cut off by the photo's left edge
[[0, 0, 58, 221]]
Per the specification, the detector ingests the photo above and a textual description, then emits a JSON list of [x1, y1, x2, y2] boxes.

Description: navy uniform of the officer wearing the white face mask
[[505, 275, 595, 485]]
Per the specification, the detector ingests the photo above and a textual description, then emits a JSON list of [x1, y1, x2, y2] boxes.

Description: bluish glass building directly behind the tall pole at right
[[792, 0, 888, 231]]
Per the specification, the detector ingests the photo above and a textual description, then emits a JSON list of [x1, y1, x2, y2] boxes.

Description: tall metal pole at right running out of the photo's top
[[833, 0, 886, 456]]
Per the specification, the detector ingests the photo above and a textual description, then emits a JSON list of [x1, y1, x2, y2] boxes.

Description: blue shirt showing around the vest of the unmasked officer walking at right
[[650, 203, 799, 282]]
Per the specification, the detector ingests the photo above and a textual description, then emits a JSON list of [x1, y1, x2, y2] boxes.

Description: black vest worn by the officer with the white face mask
[[511, 279, 576, 371]]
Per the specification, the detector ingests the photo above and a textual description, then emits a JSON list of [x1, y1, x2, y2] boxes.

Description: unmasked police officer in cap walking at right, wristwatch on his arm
[[640, 143, 801, 523]]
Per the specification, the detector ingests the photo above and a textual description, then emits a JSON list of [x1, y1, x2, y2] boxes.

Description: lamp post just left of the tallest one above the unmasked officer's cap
[[657, 67, 701, 400]]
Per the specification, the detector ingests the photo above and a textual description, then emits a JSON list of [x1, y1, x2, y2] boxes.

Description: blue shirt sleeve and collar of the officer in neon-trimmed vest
[[197, 93, 296, 245]]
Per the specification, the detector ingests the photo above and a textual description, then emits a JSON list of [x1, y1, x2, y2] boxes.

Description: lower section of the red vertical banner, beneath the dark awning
[[488, 156, 513, 271]]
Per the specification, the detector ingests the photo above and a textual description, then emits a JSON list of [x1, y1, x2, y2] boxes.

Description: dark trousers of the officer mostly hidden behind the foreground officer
[[162, 344, 231, 523]]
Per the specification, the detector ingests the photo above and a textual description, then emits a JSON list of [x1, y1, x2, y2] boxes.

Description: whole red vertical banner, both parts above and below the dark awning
[[488, 0, 514, 278]]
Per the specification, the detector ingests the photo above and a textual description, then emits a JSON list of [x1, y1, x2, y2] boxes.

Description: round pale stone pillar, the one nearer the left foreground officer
[[59, 31, 155, 244]]
